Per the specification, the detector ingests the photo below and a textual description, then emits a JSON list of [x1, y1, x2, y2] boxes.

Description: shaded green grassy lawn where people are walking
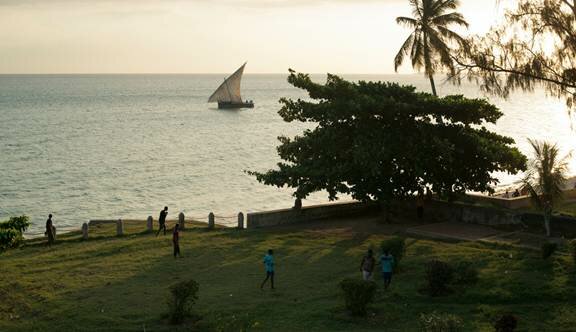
[[0, 221, 576, 331]]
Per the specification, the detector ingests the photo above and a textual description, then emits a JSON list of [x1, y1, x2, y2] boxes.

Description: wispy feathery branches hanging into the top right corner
[[452, 0, 576, 107]]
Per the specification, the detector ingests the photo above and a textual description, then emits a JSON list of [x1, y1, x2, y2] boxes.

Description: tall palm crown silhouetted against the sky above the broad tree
[[394, 0, 468, 96]]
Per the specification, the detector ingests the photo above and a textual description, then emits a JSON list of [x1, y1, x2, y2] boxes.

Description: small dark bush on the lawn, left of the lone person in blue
[[168, 280, 199, 324]]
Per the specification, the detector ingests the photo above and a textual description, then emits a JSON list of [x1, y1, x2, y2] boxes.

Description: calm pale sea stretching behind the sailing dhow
[[0, 74, 576, 236]]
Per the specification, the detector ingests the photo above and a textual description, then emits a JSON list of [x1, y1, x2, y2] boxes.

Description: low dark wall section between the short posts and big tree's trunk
[[246, 202, 379, 228]]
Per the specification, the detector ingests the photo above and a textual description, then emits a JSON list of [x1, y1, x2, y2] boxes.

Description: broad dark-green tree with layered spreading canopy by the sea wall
[[251, 71, 526, 202]]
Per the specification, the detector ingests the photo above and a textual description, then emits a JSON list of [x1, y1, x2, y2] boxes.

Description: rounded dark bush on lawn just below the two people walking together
[[340, 279, 376, 316]]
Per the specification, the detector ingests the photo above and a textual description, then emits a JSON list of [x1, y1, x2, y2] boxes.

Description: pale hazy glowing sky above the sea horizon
[[0, 0, 501, 73]]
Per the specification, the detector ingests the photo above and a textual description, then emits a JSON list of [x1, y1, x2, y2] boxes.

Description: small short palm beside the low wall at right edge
[[524, 139, 569, 236]]
